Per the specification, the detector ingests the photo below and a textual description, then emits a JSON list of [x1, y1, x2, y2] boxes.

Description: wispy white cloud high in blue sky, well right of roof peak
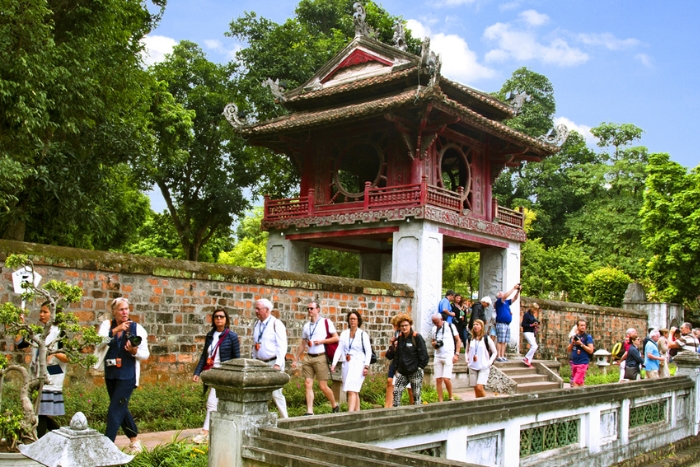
[[484, 23, 589, 66]]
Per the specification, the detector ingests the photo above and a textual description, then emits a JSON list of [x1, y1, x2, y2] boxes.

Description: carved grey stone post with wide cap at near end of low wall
[[202, 358, 289, 467]]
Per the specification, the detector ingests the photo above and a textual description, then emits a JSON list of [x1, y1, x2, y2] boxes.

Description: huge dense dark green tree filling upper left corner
[[0, 0, 165, 247]]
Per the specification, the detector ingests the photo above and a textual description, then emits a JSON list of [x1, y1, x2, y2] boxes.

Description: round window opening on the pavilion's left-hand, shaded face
[[333, 143, 384, 199]]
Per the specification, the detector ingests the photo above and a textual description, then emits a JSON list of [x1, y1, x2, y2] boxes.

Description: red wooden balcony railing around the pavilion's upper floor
[[265, 180, 524, 229]]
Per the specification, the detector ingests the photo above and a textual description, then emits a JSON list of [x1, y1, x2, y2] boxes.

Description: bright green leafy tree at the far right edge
[[640, 154, 700, 308]]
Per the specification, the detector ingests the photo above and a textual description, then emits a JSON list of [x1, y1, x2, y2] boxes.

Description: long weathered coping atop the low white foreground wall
[[278, 376, 695, 442]]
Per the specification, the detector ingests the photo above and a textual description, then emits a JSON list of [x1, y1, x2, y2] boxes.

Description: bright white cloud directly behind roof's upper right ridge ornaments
[[406, 19, 495, 84]]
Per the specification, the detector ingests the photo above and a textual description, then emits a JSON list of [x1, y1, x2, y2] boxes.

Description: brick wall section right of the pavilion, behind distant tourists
[[520, 297, 647, 364]]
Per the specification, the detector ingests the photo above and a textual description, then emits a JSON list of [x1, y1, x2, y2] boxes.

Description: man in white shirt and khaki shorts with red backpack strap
[[292, 302, 340, 415]]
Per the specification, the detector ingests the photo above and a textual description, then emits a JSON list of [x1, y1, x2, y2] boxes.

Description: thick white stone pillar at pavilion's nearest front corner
[[391, 219, 442, 336]]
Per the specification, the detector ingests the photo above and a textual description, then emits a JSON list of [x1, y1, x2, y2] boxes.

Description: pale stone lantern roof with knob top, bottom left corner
[[19, 412, 134, 467]]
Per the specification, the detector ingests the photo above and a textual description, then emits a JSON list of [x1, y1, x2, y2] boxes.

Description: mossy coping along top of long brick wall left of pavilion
[[0, 240, 414, 297]]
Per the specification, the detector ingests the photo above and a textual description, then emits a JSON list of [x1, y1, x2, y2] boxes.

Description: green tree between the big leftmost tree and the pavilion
[[141, 41, 262, 261]]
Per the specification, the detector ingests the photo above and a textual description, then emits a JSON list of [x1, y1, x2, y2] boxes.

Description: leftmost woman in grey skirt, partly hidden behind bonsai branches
[[15, 301, 68, 438]]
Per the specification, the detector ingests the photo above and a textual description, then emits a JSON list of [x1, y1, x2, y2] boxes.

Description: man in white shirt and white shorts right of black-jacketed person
[[430, 313, 462, 402]]
